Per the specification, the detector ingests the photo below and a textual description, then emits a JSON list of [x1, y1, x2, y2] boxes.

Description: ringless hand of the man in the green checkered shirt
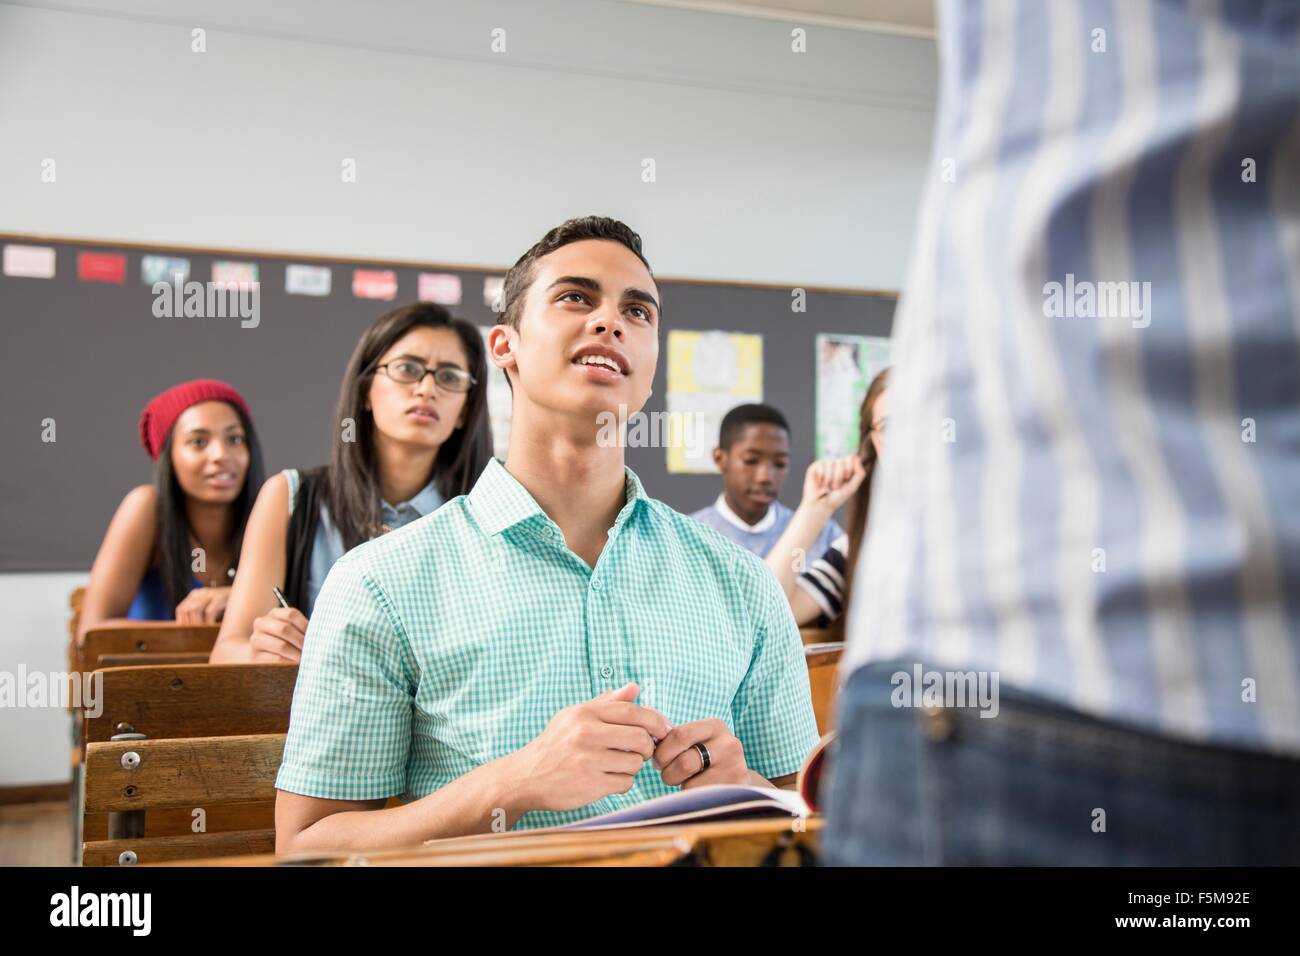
[[511, 684, 671, 810]]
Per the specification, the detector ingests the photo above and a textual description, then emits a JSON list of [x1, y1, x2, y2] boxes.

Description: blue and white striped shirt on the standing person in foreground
[[845, 0, 1300, 754]]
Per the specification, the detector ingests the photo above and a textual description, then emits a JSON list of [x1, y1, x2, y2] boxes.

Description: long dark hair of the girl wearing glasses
[[326, 302, 491, 549]]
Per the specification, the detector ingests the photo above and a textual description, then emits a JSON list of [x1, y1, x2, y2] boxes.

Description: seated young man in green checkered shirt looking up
[[276, 217, 816, 852]]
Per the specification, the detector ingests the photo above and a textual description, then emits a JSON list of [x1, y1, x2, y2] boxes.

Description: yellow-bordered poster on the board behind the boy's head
[[668, 330, 763, 475]]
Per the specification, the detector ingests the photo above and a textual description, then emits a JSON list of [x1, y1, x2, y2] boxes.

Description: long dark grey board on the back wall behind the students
[[0, 234, 894, 571]]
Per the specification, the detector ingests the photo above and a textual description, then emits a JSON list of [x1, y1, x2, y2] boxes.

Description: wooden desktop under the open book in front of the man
[[160, 817, 823, 866]]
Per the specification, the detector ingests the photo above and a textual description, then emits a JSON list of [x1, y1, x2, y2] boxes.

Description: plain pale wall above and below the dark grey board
[[0, 0, 936, 786]]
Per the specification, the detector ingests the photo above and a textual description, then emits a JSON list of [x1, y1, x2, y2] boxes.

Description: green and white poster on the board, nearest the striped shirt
[[816, 333, 889, 458]]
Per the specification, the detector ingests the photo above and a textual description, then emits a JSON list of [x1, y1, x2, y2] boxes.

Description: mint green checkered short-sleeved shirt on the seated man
[[276, 459, 818, 827]]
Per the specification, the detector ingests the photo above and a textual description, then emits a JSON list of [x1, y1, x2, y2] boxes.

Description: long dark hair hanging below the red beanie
[[153, 405, 264, 607]]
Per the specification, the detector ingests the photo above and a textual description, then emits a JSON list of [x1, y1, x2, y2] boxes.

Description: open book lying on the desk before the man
[[546, 731, 835, 832]]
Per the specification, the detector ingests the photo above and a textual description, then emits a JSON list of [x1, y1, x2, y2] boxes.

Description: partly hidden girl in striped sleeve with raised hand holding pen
[[767, 368, 889, 628]]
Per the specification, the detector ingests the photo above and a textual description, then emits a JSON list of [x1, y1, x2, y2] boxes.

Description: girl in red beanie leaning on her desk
[[78, 378, 263, 639]]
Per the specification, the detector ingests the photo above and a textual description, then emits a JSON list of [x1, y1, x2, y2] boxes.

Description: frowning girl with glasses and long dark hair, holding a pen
[[211, 303, 491, 663]]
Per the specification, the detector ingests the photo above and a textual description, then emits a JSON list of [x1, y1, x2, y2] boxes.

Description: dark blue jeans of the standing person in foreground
[[822, 661, 1300, 866]]
